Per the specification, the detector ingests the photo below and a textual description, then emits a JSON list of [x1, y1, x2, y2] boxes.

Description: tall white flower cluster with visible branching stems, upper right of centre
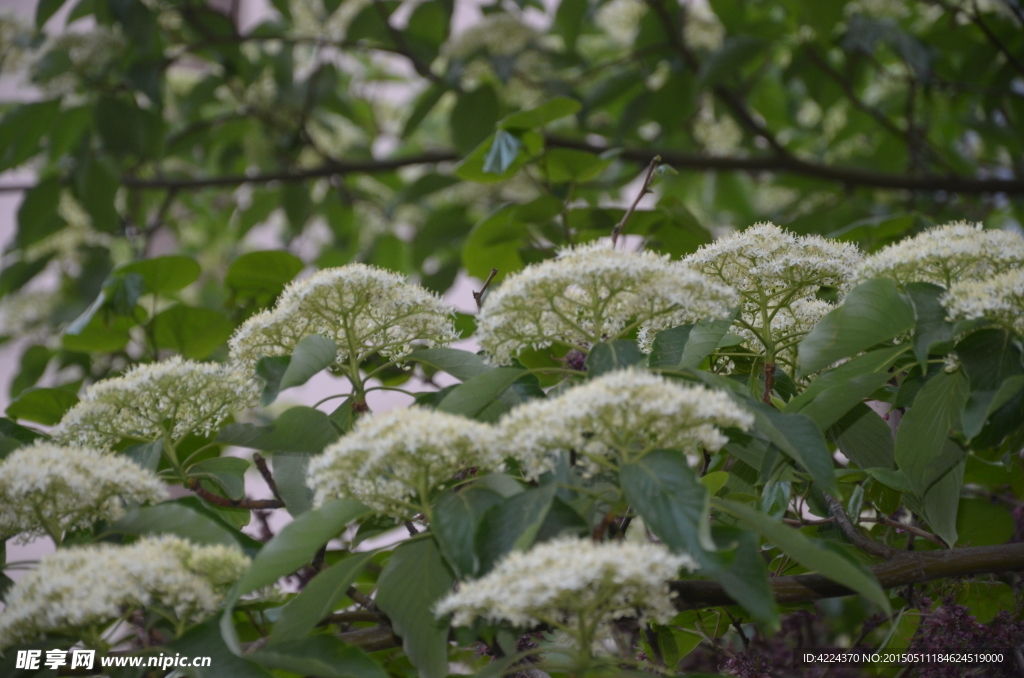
[[682, 223, 861, 363]]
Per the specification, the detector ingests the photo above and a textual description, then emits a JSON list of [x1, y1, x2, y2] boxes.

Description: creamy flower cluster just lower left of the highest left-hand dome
[[53, 356, 259, 448]]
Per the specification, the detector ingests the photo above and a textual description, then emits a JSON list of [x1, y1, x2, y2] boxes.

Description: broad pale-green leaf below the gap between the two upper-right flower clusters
[[798, 278, 915, 376]]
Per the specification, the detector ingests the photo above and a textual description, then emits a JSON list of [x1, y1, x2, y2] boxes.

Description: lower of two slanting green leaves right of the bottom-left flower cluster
[[268, 551, 377, 647]]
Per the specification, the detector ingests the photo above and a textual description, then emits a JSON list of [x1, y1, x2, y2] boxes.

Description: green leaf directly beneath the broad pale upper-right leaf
[[785, 345, 909, 430]]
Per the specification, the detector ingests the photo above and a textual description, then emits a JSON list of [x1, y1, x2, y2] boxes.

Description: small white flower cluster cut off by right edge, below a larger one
[[943, 268, 1024, 335]]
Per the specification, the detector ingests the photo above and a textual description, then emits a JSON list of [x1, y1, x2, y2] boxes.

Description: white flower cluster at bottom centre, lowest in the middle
[[434, 538, 694, 629]]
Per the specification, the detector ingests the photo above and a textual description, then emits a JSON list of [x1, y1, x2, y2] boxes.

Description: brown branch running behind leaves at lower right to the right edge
[[670, 544, 1024, 610]]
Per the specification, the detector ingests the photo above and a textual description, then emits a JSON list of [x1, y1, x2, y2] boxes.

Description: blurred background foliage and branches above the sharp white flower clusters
[[0, 0, 1024, 396]]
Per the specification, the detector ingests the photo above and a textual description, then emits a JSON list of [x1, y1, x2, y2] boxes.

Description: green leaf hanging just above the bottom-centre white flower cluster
[[430, 484, 503, 577]]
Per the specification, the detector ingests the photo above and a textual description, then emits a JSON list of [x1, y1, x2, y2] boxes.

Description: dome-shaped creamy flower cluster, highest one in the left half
[[228, 263, 459, 369]]
